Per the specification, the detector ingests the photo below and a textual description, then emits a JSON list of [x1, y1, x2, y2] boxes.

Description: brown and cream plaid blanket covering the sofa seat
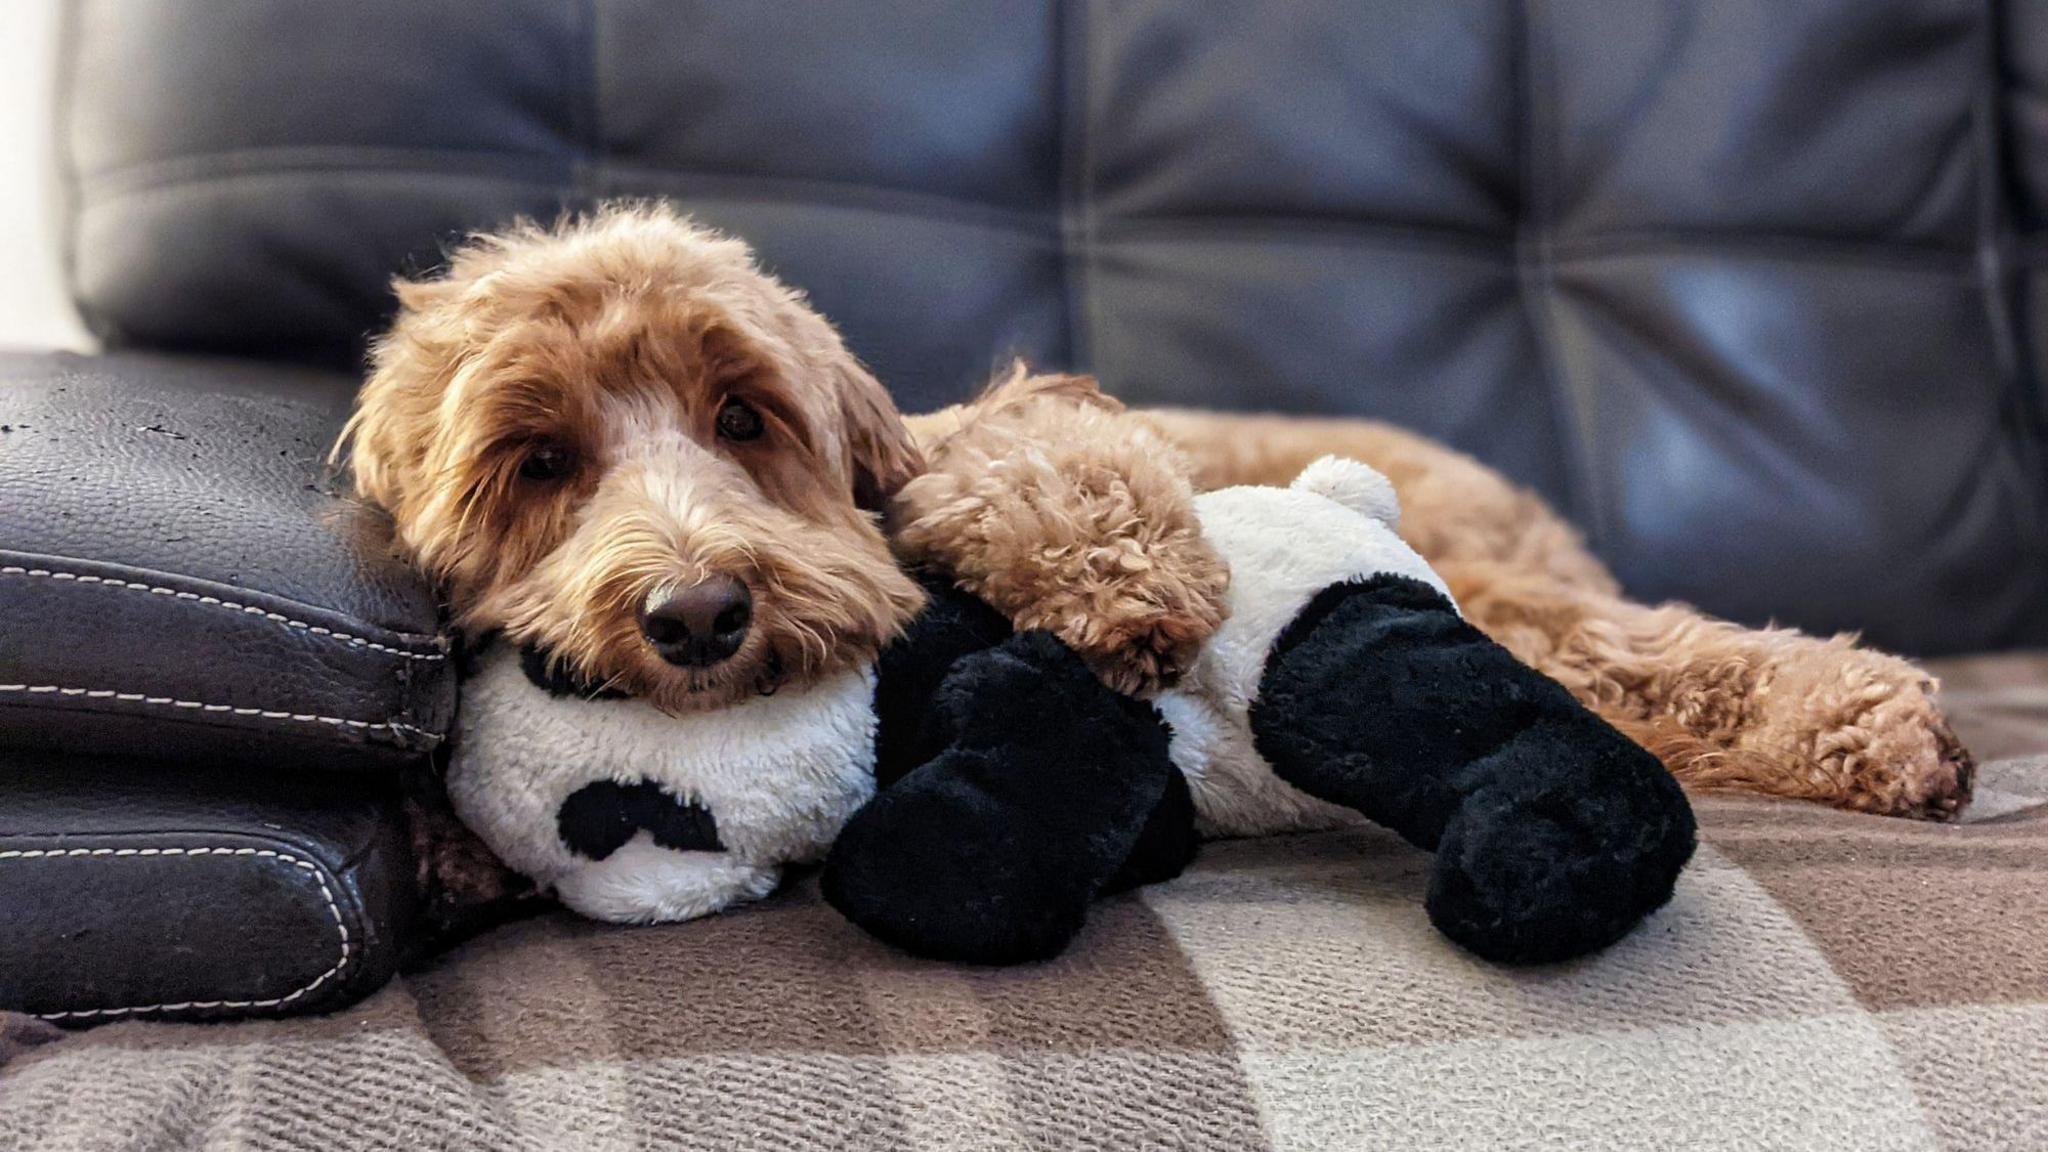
[[0, 660, 2048, 1152]]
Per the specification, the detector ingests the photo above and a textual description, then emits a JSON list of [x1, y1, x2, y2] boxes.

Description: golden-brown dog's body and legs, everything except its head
[[913, 399, 1972, 820]]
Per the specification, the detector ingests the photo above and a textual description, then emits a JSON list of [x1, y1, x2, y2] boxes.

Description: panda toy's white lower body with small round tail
[[1155, 457, 1450, 836]]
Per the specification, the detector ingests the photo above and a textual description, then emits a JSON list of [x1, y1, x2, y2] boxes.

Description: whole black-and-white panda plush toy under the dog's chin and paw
[[449, 457, 1694, 963]]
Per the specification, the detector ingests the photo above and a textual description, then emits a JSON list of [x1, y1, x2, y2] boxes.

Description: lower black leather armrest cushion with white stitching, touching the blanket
[[0, 752, 414, 1025]]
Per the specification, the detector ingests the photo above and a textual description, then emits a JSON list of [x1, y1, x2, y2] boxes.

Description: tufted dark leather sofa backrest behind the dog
[[48, 0, 2048, 652]]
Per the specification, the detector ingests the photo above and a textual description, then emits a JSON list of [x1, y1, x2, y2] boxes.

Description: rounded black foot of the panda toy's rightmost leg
[[1427, 726, 1694, 963]]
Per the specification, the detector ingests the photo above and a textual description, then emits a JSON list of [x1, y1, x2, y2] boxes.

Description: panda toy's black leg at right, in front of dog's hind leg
[[1251, 576, 1694, 963]]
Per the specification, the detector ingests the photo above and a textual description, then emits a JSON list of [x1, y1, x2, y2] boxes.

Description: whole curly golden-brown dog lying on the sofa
[[336, 205, 1972, 820]]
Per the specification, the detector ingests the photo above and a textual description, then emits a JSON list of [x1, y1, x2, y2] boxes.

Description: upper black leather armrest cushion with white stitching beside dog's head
[[0, 344, 455, 767]]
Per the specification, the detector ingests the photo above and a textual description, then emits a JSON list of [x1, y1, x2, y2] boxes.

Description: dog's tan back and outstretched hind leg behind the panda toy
[[1145, 403, 1972, 820]]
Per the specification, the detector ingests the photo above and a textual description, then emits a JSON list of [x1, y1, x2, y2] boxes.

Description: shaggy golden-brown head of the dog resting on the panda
[[336, 205, 922, 711]]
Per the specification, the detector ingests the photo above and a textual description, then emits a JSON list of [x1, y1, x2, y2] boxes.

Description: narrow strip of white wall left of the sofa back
[[0, 0, 90, 348]]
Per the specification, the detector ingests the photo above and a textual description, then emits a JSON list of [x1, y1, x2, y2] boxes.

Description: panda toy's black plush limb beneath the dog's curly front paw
[[823, 633, 1176, 963]]
